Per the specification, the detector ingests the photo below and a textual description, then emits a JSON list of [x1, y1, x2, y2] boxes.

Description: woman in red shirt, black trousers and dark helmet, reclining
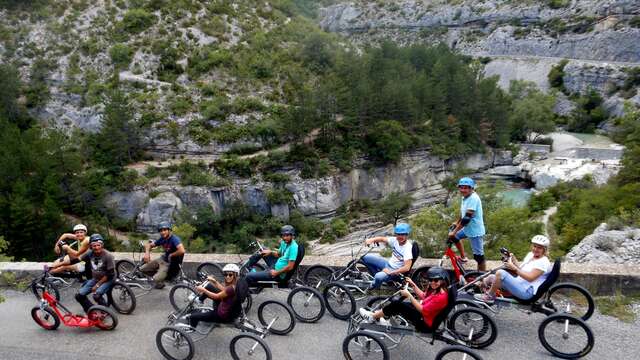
[[360, 267, 449, 332]]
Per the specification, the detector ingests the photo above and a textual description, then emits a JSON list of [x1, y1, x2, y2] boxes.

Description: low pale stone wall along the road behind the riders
[[0, 253, 640, 296]]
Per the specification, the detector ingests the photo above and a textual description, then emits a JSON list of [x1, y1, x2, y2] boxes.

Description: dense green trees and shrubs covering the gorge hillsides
[[0, 0, 640, 259]]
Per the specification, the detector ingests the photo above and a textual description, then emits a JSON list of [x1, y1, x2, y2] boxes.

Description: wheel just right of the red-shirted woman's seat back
[[447, 307, 498, 349]]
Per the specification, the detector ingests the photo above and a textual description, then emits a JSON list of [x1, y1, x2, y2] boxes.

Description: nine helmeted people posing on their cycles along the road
[[45, 177, 551, 331]]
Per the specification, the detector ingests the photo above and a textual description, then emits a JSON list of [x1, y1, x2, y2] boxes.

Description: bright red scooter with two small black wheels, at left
[[31, 269, 118, 330]]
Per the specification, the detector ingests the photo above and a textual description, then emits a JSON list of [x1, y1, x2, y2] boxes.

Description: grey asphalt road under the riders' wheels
[[0, 289, 640, 360]]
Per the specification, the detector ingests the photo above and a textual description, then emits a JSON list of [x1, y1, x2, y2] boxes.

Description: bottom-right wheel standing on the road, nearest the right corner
[[538, 314, 594, 359]]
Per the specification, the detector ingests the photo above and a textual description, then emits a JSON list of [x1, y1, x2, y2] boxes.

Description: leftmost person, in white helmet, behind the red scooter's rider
[[49, 224, 89, 274]]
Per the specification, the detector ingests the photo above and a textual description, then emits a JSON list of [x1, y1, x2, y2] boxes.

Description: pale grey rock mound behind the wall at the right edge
[[565, 223, 640, 265]]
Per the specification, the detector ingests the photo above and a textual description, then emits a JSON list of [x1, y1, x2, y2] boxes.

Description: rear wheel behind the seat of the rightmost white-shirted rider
[[545, 283, 595, 321]]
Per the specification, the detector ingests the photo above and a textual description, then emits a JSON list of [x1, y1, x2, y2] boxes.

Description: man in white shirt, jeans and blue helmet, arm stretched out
[[362, 223, 413, 289]]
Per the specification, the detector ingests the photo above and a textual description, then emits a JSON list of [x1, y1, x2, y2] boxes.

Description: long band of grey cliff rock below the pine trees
[[112, 150, 512, 231]]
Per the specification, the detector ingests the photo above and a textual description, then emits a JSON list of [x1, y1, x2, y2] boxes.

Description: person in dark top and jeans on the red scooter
[[76, 234, 116, 312]]
